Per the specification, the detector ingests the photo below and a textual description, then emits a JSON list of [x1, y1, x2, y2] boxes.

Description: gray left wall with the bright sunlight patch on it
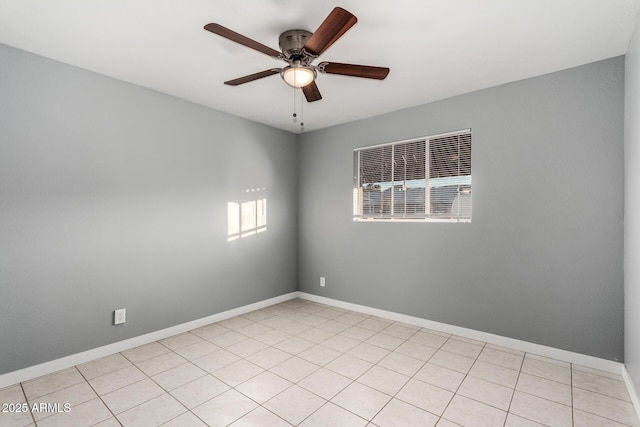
[[0, 45, 297, 374]]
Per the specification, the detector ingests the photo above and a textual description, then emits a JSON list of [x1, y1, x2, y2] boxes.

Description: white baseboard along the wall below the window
[[298, 292, 624, 375]]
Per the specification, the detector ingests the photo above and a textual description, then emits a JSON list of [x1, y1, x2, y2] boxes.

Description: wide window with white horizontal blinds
[[353, 130, 471, 222]]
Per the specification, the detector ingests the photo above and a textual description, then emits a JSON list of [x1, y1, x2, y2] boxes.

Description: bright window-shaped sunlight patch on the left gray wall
[[227, 188, 267, 242]]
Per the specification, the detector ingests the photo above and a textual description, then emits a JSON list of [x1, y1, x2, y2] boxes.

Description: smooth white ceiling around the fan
[[0, 0, 640, 132]]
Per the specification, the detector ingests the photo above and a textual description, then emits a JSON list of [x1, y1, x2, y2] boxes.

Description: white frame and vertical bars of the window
[[352, 129, 472, 223]]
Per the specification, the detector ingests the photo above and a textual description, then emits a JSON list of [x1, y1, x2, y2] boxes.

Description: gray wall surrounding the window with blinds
[[298, 57, 624, 360]]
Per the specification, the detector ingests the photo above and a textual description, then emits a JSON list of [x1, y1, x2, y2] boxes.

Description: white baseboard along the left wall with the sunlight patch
[[0, 291, 299, 389]]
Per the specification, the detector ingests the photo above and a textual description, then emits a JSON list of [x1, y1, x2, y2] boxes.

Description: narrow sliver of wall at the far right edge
[[624, 20, 640, 390]]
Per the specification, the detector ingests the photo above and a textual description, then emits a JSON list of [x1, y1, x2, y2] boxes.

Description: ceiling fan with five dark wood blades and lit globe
[[204, 7, 389, 102]]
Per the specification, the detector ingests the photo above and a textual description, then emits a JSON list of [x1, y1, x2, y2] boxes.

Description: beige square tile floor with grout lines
[[0, 300, 640, 427]]
